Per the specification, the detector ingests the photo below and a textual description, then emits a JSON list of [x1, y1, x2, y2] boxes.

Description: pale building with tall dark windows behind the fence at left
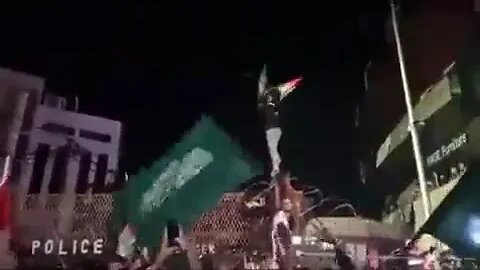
[[20, 95, 122, 196]]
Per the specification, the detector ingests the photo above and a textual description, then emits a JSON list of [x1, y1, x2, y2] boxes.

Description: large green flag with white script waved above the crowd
[[124, 117, 263, 247]]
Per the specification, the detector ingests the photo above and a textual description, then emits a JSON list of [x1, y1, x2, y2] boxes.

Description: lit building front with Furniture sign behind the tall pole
[[368, 62, 480, 249]]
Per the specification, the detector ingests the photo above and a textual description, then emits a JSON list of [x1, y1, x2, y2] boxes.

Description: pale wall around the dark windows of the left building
[[20, 105, 122, 194]]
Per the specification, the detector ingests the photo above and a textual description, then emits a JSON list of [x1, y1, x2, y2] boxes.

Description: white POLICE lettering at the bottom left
[[32, 239, 104, 256]]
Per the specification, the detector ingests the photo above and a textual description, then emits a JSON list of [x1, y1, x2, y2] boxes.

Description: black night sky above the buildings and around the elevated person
[[0, 1, 385, 205]]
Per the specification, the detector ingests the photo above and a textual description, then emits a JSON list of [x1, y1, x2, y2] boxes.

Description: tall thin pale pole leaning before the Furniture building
[[390, 0, 431, 220]]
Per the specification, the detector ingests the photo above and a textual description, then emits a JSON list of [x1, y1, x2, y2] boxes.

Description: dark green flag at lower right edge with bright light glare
[[418, 164, 480, 258]]
